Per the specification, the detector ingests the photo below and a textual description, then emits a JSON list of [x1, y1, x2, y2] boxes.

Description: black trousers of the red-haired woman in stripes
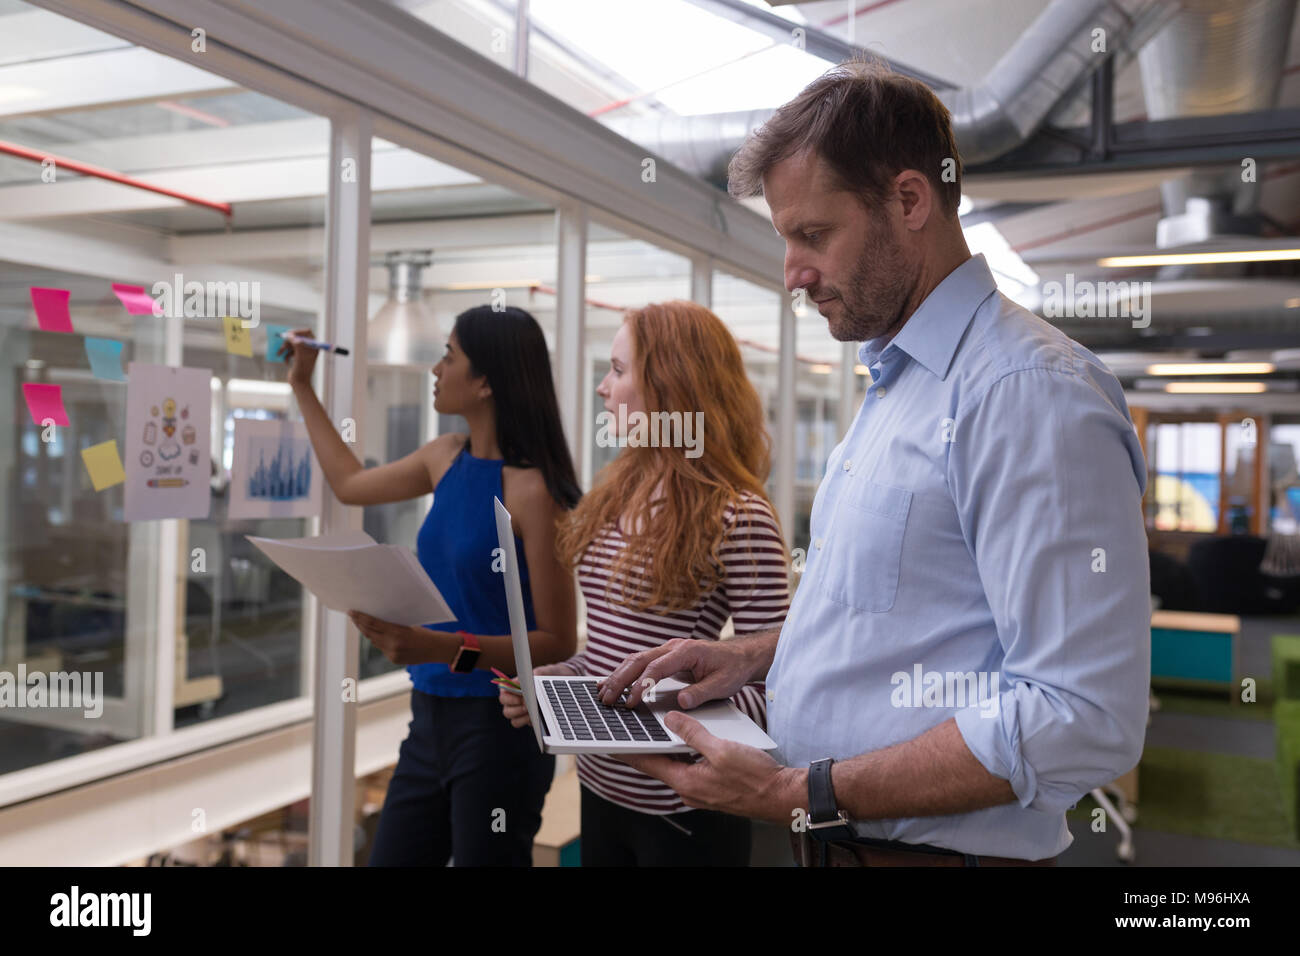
[[581, 787, 753, 866]]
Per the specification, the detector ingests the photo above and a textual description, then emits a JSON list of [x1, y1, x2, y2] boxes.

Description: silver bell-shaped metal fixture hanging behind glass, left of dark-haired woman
[[365, 248, 442, 368]]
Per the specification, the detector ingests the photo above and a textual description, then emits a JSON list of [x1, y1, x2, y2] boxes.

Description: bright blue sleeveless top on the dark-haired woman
[[407, 449, 537, 697]]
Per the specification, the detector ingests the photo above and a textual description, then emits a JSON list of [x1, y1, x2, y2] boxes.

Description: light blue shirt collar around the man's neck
[[858, 254, 997, 378]]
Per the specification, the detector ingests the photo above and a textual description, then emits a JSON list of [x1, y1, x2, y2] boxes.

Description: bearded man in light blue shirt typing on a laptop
[[605, 59, 1151, 865]]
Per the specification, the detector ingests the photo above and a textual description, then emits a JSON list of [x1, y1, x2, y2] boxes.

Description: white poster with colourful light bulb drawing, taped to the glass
[[122, 362, 212, 522]]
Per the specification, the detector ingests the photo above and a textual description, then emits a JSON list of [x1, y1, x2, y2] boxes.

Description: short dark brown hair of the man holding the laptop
[[727, 57, 962, 216]]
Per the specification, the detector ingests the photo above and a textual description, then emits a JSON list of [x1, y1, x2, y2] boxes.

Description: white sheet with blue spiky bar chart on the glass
[[229, 419, 325, 518]]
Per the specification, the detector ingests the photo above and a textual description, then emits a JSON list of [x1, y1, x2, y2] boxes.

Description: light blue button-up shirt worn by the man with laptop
[[767, 256, 1151, 860]]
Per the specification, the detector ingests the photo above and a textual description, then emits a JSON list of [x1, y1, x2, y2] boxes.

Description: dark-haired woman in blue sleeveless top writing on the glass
[[286, 306, 581, 866]]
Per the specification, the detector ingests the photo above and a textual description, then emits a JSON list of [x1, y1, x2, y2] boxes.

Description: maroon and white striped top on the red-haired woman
[[564, 492, 789, 814]]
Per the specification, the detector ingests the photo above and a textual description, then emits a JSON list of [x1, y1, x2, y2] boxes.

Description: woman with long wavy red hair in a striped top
[[499, 300, 789, 866]]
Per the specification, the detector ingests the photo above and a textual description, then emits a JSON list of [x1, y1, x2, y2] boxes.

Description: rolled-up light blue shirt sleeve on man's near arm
[[948, 367, 1151, 812]]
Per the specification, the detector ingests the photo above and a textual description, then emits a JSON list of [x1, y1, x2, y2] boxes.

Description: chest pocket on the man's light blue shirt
[[822, 481, 911, 613]]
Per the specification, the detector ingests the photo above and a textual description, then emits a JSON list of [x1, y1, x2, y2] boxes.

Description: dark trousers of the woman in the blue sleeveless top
[[371, 689, 555, 866]]
